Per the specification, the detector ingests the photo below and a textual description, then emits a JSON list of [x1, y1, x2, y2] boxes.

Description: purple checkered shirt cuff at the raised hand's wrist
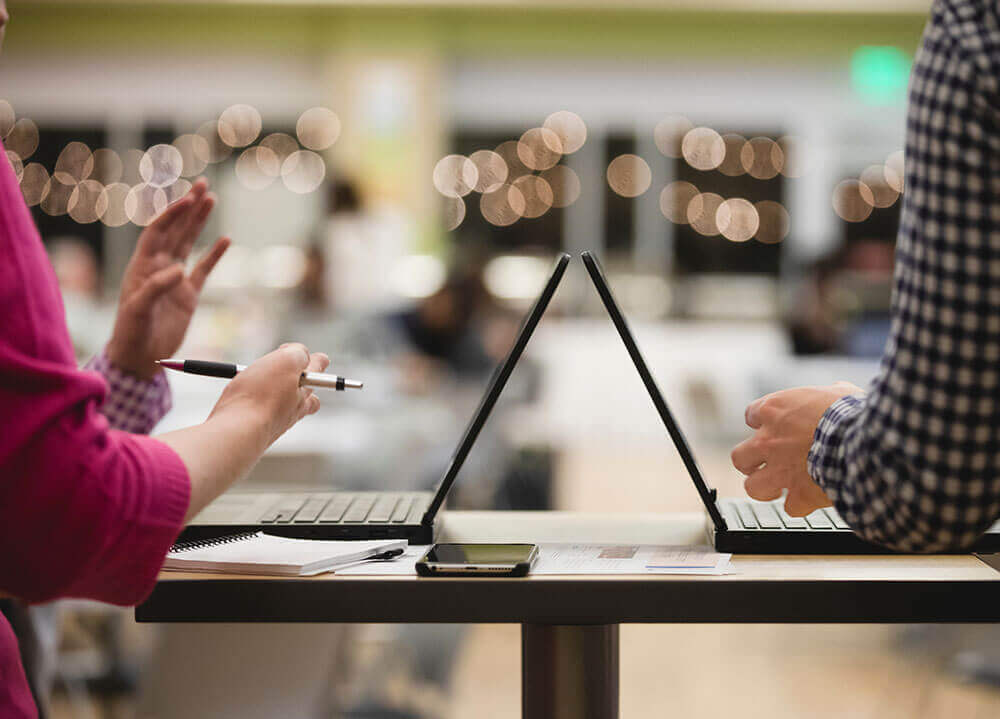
[[84, 351, 173, 434]]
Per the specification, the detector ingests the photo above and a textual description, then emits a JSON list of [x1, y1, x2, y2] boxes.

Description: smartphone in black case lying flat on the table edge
[[417, 544, 538, 577]]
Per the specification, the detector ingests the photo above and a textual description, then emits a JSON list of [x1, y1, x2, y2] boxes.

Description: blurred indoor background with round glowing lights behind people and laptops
[[0, 0, 1000, 717]]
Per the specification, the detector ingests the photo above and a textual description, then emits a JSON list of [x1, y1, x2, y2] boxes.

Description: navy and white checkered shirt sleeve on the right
[[808, 0, 1000, 552]]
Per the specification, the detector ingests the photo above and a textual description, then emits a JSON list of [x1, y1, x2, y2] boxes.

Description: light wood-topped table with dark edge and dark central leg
[[136, 512, 1000, 719]]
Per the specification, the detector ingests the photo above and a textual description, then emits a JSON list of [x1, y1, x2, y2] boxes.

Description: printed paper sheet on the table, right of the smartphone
[[531, 544, 733, 575]]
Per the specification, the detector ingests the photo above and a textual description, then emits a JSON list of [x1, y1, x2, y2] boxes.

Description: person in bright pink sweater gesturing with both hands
[[0, 5, 329, 717]]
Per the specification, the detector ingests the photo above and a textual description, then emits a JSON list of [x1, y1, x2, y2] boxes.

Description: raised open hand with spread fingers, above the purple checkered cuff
[[107, 178, 229, 379]]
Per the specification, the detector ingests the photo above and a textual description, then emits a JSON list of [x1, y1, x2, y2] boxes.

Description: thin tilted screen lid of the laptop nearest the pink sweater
[[422, 253, 569, 524]]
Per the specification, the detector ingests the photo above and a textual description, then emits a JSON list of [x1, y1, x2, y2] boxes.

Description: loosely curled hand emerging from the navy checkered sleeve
[[732, 382, 863, 517]]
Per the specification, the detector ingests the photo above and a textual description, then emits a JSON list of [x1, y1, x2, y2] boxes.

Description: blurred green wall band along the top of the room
[[6, 0, 925, 60]]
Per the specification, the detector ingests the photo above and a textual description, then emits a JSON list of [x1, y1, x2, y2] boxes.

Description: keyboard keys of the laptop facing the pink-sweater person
[[260, 494, 416, 524]]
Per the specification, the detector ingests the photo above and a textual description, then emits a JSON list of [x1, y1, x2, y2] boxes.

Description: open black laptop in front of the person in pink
[[181, 254, 569, 544]]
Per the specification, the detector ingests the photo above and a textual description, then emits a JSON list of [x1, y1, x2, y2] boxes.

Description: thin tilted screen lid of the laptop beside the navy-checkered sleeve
[[583, 252, 726, 530]]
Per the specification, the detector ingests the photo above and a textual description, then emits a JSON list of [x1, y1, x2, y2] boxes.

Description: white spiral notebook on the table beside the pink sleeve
[[163, 532, 407, 577]]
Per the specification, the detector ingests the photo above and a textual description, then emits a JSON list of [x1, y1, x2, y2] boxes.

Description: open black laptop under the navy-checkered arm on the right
[[583, 252, 1000, 554]]
